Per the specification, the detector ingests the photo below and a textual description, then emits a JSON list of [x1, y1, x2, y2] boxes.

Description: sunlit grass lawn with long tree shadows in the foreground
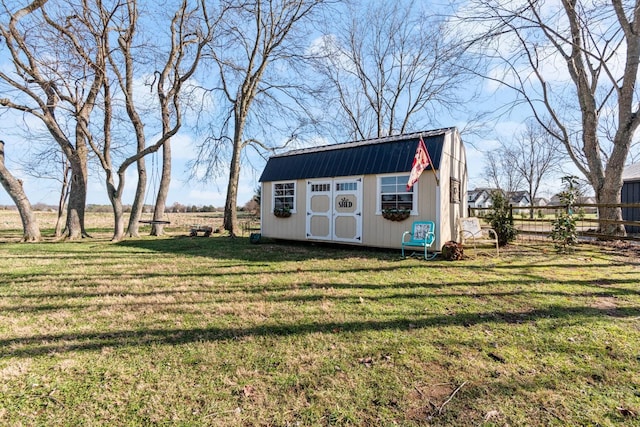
[[0, 232, 640, 426]]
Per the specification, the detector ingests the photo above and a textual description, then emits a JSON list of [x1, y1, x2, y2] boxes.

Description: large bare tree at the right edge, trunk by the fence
[[461, 0, 640, 235]]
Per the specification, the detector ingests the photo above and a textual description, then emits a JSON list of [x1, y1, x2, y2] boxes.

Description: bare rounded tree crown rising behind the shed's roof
[[315, 0, 471, 139]]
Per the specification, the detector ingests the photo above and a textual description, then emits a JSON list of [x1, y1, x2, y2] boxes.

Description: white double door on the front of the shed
[[306, 177, 362, 243]]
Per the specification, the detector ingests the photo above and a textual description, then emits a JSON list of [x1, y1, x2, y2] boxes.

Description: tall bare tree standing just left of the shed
[[196, 0, 328, 236]]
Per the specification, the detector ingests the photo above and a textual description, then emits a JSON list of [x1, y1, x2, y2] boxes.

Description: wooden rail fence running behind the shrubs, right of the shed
[[469, 203, 640, 241]]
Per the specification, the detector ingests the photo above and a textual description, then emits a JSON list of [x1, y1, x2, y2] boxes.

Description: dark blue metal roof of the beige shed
[[260, 128, 453, 182]]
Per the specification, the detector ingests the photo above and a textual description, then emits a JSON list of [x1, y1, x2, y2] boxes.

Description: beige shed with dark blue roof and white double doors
[[260, 128, 467, 249]]
